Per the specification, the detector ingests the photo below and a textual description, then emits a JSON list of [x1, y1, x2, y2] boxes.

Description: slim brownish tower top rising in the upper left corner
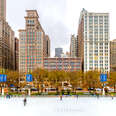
[[0, 0, 6, 20]]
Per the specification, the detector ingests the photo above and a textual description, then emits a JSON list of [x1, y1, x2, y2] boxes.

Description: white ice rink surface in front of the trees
[[0, 97, 116, 116]]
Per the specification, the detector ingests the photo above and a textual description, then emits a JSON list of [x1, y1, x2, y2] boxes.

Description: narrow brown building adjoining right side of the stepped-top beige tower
[[43, 35, 50, 57]]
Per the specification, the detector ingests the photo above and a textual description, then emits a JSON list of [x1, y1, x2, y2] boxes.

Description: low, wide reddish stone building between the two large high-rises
[[44, 58, 82, 72]]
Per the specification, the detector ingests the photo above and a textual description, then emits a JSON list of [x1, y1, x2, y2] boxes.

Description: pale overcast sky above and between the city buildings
[[7, 0, 116, 56]]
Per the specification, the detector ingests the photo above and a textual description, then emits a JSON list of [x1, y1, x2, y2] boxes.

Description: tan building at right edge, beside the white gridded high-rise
[[110, 39, 116, 71]]
